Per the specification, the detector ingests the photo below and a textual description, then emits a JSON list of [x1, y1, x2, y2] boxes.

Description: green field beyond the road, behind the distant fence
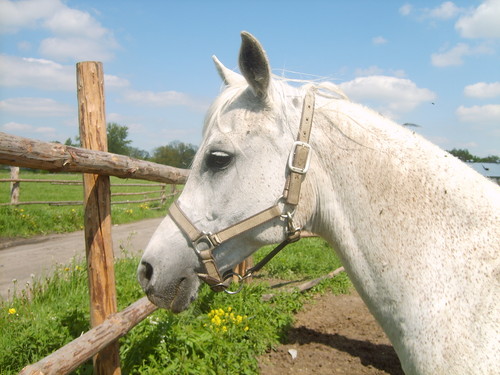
[[0, 170, 178, 240]]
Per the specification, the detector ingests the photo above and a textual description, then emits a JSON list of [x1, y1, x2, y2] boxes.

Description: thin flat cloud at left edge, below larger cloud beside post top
[[0, 98, 75, 117]]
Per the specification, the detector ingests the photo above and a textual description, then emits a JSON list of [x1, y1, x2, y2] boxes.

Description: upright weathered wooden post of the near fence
[[76, 61, 121, 375]]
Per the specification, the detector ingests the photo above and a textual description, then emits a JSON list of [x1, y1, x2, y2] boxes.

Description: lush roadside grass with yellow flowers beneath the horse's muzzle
[[0, 238, 350, 374]]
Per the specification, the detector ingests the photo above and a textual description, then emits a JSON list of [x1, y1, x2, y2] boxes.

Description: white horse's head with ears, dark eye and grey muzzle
[[138, 32, 313, 312]]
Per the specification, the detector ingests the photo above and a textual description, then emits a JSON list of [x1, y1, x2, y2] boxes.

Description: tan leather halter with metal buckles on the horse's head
[[169, 91, 314, 294]]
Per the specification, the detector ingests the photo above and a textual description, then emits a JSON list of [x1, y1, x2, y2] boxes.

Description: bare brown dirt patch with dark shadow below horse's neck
[[259, 291, 404, 375]]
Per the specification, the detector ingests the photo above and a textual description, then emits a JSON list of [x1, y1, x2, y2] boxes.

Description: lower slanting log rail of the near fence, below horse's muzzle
[[19, 297, 157, 375]]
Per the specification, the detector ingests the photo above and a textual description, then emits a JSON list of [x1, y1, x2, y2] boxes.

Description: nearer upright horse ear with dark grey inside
[[239, 31, 271, 99]]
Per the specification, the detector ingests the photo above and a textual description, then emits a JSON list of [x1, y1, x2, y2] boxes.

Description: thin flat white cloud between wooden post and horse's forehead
[[123, 90, 208, 111]]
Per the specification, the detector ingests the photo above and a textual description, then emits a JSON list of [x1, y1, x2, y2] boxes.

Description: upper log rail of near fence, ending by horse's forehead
[[0, 132, 189, 184]]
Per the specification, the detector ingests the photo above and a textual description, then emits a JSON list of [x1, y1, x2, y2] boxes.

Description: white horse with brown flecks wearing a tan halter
[[138, 32, 500, 375]]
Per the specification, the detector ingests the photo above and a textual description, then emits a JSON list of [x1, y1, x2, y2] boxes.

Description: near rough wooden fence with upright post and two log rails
[[0, 62, 188, 375]]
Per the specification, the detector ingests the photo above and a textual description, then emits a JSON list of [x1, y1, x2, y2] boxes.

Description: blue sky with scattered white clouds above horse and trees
[[0, 0, 500, 156]]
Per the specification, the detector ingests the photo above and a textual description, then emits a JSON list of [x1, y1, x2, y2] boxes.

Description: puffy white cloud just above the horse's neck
[[340, 75, 436, 118]]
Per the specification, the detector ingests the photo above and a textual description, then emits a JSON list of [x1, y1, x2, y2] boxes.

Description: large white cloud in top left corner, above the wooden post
[[0, 0, 119, 61]]
